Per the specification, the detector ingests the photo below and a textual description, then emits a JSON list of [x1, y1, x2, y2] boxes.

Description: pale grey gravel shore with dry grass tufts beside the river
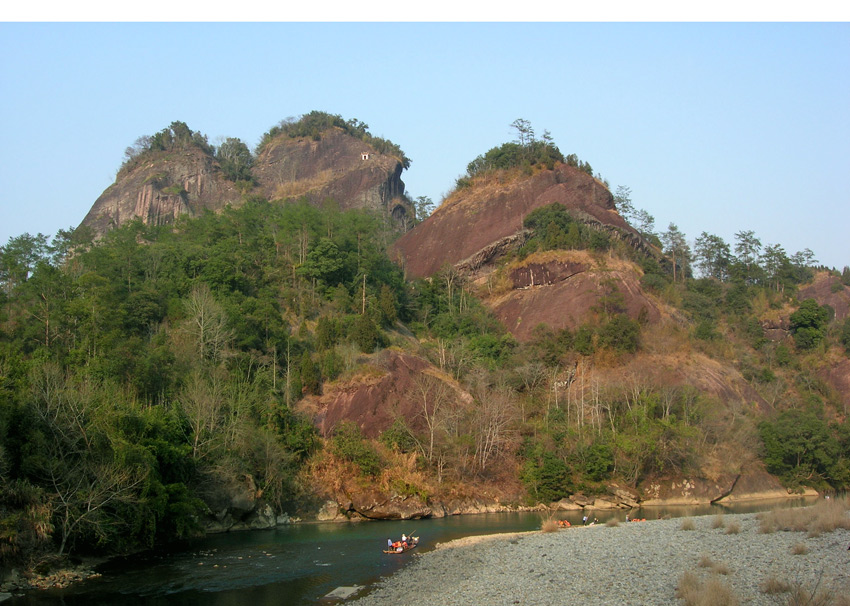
[[349, 514, 850, 606]]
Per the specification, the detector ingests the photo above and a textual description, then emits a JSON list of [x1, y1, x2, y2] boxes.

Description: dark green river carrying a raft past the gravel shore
[[4, 499, 812, 606]]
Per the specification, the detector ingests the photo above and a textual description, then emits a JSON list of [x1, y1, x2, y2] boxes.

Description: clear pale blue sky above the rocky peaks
[[0, 16, 850, 270]]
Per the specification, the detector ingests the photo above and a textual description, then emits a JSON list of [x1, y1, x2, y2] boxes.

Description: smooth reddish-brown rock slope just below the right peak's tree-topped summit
[[393, 164, 635, 278]]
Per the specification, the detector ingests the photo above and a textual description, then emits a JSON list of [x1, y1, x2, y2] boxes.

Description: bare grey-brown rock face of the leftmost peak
[[82, 148, 240, 235]]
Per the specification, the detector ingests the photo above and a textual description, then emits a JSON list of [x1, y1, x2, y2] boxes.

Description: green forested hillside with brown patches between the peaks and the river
[[0, 117, 850, 576]]
